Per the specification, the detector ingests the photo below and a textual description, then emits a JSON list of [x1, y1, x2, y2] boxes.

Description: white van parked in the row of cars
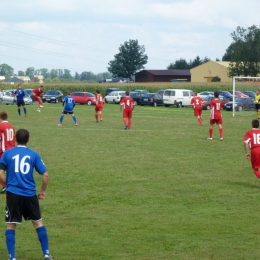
[[163, 89, 193, 107]]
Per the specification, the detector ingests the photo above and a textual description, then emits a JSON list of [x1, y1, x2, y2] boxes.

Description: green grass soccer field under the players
[[0, 104, 260, 260]]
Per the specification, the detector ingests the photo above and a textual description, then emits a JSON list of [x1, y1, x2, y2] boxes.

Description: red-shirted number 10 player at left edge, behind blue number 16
[[0, 110, 15, 193]]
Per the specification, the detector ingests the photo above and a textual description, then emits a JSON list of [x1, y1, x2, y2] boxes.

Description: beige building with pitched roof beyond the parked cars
[[190, 61, 232, 82]]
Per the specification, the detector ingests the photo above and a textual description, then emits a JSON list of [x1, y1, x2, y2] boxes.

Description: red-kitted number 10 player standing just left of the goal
[[208, 92, 223, 141]]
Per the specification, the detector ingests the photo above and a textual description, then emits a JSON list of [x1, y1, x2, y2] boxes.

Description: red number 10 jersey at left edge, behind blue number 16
[[0, 121, 15, 158]]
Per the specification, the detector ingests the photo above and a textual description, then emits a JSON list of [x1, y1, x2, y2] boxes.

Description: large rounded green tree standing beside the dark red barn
[[108, 40, 148, 78]]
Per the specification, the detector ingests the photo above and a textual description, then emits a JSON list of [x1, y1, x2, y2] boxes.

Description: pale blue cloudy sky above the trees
[[0, 0, 260, 75]]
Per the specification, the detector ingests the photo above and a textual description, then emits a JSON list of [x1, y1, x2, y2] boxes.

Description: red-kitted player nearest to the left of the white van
[[120, 91, 135, 130]]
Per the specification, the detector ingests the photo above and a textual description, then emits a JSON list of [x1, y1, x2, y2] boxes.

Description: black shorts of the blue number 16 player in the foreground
[[5, 192, 42, 224]]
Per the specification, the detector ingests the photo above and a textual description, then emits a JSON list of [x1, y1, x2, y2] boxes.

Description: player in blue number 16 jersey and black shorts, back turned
[[0, 129, 53, 260]]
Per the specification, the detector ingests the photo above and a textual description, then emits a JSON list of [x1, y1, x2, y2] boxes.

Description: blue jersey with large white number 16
[[0, 146, 47, 197]]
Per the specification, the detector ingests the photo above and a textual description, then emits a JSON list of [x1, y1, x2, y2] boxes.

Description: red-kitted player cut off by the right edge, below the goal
[[243, 119, 260, 178]]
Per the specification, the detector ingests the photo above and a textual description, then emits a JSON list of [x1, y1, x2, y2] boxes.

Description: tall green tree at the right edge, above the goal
[[227, 25, 260, 76]]
